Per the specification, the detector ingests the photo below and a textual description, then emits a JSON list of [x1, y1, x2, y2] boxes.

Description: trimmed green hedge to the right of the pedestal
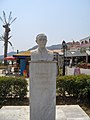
[[57, 74, 90, 99]]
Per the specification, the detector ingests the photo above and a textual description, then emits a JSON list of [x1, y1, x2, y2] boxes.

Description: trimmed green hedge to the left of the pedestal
[[0, 77, 28, 99]]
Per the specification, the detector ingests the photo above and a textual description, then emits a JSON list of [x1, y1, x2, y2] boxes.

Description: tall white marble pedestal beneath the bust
[[30, 61, 56, 120]]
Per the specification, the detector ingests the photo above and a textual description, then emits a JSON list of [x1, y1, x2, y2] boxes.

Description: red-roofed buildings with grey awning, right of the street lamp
[[65, 36, 90, 64]]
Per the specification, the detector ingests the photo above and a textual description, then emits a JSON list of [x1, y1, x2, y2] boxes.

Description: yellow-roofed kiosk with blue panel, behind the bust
[[13, 50, 62, 75]]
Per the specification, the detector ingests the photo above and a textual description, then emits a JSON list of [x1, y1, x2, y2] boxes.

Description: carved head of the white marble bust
[[36, 34, 47, 48]]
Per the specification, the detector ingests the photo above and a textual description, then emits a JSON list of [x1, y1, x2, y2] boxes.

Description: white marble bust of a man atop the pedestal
[[31, 34, 53, 61]]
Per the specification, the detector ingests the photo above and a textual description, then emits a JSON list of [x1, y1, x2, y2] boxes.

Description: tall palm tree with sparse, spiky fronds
[[0, 11, 16, 65]]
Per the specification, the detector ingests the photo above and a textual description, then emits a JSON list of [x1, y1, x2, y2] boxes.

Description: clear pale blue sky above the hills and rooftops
[[0, 0, 90, 55]]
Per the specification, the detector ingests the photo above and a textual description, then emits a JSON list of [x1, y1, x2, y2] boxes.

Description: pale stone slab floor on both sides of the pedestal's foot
[[0, 105, 90, 120]]
